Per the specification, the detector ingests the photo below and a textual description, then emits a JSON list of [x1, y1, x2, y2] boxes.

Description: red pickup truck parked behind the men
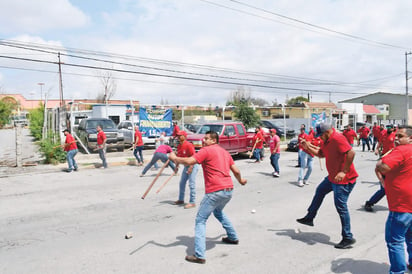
[[187, 121, 270, 154]]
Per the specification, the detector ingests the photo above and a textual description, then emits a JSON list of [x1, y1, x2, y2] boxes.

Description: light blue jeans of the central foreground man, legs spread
[[195, 190, 238, 259]]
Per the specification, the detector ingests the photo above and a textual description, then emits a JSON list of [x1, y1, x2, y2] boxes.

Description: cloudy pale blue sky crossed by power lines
[[0, 0, 412, 105]]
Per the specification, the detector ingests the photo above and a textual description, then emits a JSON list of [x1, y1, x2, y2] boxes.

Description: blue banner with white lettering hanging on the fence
[[139, 107, 173, 137]]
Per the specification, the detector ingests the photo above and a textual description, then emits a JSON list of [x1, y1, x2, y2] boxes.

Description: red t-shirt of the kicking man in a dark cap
[[320, 129, 358, 185]]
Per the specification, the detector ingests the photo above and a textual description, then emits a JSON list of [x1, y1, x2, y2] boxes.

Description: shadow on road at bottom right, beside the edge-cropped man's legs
[[330, 258, 389, 274]]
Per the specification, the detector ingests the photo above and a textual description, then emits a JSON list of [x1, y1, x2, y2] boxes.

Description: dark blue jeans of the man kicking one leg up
[[305, 177, 355, 239]]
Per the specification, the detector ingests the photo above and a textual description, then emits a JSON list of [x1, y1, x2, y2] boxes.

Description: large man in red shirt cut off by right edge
[[375, 126, 412, 273]]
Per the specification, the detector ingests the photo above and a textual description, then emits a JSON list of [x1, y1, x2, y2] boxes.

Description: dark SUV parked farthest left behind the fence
[[76, 118, 124, 151]]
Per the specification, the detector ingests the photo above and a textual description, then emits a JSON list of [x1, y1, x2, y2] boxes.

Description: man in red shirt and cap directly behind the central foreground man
[[175, 130, 199, 209]]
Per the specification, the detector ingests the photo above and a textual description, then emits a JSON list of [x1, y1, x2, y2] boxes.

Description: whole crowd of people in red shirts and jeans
[[58, 120, 412, 273]]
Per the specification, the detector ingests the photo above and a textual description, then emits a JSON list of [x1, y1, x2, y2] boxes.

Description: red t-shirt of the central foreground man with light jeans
[[193, 144, 234, 193]]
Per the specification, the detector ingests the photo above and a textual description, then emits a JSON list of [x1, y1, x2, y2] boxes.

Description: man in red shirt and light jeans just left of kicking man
[[298, 128, 313, 187]]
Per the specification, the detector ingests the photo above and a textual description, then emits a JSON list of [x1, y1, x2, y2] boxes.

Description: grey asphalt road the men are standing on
[[0, 144, 389, 274]]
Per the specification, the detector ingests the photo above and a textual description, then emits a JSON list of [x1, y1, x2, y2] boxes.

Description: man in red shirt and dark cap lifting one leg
[[296, 123, 358, 249]]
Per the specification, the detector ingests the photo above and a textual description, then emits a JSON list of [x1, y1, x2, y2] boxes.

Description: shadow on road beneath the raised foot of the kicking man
[[268, 229, 335, 245]]
